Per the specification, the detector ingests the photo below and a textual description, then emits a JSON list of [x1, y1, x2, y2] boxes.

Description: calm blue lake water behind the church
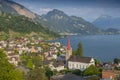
[[55, 35, 120, 62]]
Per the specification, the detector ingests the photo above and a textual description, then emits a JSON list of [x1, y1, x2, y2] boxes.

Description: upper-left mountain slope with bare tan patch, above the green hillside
[[0, 0, 37, 19]]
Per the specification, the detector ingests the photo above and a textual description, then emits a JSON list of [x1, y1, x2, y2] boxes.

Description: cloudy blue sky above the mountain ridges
[[13, 0, 120, 22]]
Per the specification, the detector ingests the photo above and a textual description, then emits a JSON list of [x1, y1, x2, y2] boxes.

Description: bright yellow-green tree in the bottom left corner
[[0, 49, 24, 80]]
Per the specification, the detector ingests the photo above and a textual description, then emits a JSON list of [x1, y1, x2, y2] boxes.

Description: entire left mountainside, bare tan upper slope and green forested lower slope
[[0, 0, 58, 39]]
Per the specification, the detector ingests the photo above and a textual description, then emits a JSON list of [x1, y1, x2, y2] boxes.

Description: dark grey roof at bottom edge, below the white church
[[50, 74, 86, 80]]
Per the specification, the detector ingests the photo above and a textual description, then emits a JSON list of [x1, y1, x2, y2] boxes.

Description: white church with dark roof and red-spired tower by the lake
[[65, 37, 95, 71]]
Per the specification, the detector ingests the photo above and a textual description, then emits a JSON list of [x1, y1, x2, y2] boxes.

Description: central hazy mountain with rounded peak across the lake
[[39, 9, 102, 34]]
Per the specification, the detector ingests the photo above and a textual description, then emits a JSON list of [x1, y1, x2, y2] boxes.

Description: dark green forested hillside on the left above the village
[[0, 12, 58, 38]]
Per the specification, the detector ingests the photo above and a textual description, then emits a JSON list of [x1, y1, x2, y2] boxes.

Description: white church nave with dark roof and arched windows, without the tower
[[67, 56, 95, 70]]
